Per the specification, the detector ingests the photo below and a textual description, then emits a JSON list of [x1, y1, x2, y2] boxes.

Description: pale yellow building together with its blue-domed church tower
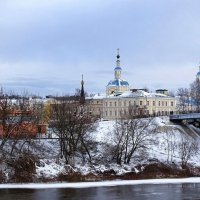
[[87, 51, 176, 120]]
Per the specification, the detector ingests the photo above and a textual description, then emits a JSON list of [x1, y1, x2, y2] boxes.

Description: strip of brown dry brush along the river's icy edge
[[0, 162, 200, 184]]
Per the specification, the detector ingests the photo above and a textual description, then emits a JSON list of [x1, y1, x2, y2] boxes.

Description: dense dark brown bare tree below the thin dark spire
[[51, 97, 94, 165]]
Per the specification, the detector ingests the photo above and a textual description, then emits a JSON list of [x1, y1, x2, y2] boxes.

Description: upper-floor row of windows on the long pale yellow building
[[105, 101, 174, 107]]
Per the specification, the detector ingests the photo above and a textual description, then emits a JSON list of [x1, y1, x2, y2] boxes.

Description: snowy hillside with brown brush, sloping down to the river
[[0, 117, 200, 182]]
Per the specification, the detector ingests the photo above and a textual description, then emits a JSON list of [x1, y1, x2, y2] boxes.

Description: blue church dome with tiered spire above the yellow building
[[106, 49, 129, 95]]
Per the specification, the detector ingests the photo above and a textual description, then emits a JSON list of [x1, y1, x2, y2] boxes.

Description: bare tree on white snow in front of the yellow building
[[111, 107, 156, 164]]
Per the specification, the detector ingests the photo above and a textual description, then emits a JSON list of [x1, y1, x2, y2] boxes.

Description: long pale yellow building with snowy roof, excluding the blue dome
[[102, 90, 176, 119]]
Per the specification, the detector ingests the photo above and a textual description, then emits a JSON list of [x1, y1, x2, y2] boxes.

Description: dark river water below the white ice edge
[[0, 183, 200, 200]]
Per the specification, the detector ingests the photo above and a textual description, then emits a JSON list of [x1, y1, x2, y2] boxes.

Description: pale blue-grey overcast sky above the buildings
[[0, 0, 200, 95]]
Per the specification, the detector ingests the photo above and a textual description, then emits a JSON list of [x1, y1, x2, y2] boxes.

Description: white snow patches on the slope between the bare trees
[[1, 117, 200, 180]]
